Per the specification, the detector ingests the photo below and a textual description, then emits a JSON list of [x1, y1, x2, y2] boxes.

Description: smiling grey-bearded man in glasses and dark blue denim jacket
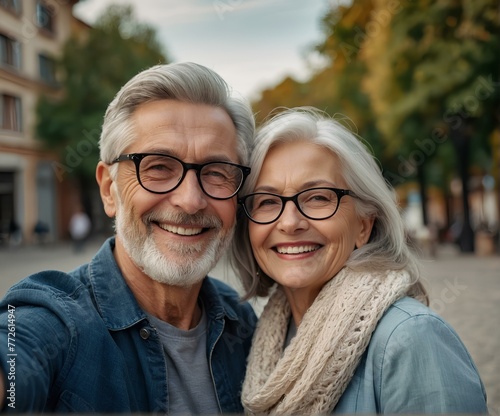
[[0, 63, 256, 414]]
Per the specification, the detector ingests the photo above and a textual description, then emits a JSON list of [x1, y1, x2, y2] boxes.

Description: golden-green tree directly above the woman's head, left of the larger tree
[[253, 0, 385, 164]]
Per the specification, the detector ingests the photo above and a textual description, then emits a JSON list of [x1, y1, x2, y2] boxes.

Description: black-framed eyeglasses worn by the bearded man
[[112, 153, 250, 199]]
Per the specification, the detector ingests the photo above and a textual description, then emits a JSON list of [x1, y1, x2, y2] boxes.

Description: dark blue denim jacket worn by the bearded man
[[0, 238, 256, 413]]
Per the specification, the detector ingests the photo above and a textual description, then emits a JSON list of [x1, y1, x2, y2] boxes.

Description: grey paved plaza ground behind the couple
[[0, 234, 500, 415]]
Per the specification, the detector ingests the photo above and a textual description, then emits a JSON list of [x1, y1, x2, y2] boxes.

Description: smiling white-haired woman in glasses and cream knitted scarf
[[231, 108, 487, 414]]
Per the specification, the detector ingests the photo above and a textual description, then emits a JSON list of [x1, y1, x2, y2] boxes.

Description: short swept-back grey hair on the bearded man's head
[[99, 62, 255, 176]]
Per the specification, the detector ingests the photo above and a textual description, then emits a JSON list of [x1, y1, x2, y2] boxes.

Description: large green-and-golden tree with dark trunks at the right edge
[[364, 0, 500, 251]]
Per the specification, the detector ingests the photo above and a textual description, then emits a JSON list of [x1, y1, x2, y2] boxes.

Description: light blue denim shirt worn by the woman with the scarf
[[335, 298, 488, 414]]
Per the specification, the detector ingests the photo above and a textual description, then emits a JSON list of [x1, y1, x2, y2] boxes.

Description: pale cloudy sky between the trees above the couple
[[74, 0, 336, 99]]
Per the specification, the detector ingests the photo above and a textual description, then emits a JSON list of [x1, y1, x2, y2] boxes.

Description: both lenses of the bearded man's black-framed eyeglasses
[[139, 155, 243, 198]]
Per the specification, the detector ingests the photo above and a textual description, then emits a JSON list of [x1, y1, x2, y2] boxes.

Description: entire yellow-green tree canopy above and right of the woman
[[254, 0, 500, 176]]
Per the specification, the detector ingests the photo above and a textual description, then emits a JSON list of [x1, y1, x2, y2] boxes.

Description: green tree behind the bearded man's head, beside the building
[[37, 6, 167, 187]]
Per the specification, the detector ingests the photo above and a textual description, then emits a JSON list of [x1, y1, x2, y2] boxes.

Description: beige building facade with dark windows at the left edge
[[0, 0, 88, 244]]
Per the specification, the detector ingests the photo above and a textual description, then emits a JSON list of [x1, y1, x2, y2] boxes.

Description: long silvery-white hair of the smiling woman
[[230, 107, 425, 298]]
